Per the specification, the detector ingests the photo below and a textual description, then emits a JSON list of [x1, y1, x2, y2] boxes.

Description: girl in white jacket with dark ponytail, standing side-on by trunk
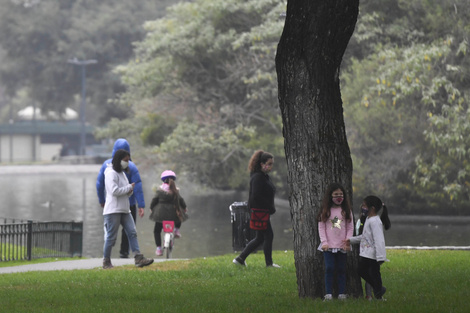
[[345, 196, 391, 299]]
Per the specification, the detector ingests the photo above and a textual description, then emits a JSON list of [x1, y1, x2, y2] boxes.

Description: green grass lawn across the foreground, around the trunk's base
[[0, 250, 470, 313]]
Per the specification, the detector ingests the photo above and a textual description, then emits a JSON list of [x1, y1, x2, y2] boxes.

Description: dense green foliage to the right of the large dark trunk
[[342, 0, 470, 214]]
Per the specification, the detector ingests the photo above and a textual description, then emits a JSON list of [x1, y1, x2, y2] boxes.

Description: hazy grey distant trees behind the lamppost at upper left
[[0, 0, 174, 124]]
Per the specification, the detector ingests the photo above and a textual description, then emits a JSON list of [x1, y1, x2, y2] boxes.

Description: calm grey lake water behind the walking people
[[0, 165, 470, 258]]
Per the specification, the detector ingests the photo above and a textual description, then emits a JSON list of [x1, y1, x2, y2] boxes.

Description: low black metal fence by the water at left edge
[[0, 218, 83, 261]]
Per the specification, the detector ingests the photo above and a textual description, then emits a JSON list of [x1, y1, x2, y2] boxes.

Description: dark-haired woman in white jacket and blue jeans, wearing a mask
[[103, 150, 153, 269]]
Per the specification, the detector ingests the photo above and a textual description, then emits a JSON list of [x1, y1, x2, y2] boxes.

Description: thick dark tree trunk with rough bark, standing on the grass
[[276, 0, 362, 298]]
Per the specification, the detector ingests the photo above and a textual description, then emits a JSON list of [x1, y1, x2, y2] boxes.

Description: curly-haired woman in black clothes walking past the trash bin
[[233, 150, 280, 268]]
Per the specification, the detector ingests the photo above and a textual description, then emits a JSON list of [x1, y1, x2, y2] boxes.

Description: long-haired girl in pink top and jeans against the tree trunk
[[318, 183, 354, 300]]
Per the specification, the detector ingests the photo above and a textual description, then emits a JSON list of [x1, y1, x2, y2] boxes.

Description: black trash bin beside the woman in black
[[229, 202, 256, 251]]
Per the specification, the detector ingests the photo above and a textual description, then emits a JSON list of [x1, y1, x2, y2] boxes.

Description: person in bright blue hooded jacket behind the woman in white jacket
[[96, 138, 145, 258]]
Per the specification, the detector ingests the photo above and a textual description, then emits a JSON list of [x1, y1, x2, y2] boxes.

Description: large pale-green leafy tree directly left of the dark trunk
[[117, 0, 285, 191]]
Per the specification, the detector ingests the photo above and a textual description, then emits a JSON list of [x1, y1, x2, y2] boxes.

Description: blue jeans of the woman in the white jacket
[[103, 213, 140, 258]]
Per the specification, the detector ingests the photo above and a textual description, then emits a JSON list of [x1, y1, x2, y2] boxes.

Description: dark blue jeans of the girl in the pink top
[[323, 251, 347, 294]]
